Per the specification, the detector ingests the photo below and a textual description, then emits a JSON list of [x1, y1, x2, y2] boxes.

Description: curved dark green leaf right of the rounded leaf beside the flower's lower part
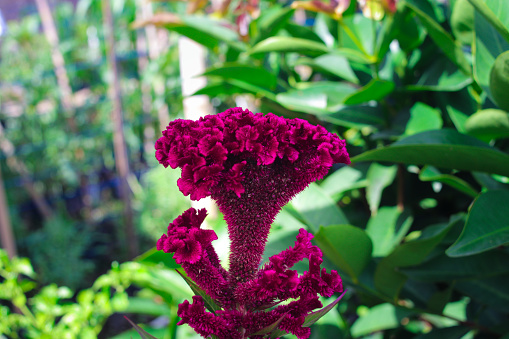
[[374, 222, 454, 300]]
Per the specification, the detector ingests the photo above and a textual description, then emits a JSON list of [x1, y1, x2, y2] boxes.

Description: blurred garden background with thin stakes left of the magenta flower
[[0, 0, 194, 288]]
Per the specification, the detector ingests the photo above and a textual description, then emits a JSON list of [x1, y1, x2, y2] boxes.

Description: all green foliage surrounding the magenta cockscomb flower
[[0, 0, 509, 338]]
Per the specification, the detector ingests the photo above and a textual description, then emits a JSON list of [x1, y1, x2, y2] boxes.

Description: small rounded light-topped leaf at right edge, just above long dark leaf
[[465, 109, 509, 140]]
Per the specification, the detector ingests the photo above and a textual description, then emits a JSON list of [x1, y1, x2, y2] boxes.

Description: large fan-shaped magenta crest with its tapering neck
[[156, 107, 350, 284]]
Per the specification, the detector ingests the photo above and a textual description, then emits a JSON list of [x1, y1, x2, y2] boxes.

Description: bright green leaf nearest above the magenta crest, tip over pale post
[[203, 63, 277, 89]]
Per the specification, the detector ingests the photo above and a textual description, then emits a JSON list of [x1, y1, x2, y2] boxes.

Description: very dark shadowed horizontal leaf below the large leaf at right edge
[[401, 251, 509, 282]]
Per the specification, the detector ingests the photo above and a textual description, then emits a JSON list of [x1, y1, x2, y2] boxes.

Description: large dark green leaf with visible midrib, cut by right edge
[[446, 191, 509, 257]]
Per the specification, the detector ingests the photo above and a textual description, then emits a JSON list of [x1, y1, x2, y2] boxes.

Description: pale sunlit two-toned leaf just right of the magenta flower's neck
[[291, 183, 348, 232]]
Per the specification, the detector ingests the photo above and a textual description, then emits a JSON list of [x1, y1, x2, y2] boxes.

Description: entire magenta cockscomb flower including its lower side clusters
[[155, 108, 350, 338]]
